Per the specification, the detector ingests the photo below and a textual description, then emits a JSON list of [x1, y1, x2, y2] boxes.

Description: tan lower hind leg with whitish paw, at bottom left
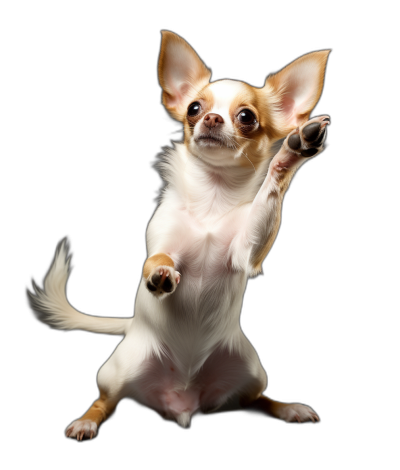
[[65, 389, 117, 441]]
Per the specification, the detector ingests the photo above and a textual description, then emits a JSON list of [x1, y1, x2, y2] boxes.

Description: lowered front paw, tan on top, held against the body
[[143, 253, 181, 298]]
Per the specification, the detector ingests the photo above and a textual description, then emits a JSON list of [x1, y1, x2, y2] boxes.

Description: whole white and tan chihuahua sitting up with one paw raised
[[28, 31, 330, 441]]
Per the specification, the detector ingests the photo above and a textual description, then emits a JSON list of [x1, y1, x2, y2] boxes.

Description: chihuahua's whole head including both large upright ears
[[158, 31, 329, 168]]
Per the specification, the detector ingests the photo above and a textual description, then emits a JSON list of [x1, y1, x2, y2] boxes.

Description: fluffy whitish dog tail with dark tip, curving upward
[[28, 238, 132, 335]]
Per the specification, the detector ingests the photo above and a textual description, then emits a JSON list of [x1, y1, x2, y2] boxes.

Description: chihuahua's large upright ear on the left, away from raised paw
[[158, 31, 211, 120]]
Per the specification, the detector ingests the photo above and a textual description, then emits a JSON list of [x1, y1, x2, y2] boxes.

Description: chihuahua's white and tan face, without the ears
[[183, 80, 273, 166]]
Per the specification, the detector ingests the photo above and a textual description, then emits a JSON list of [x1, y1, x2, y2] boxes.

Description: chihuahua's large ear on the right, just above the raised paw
[[264, 51, 330, 131]]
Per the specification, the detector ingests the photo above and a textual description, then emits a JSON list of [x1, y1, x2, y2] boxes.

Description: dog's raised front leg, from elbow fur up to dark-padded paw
[[244, 116, 329, 273]]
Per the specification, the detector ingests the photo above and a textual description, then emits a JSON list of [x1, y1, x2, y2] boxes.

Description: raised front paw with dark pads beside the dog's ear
[[284, 116, 330, 157]]
